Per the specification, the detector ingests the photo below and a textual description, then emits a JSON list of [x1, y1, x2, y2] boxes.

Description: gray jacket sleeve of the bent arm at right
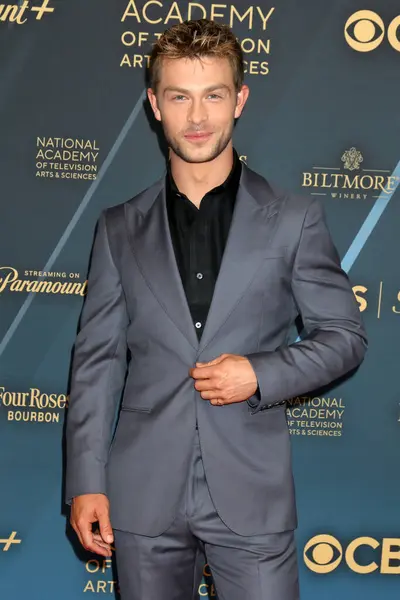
[[247, 200, 367, 413]]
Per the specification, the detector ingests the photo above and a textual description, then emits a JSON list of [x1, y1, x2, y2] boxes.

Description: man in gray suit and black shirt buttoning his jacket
[[66, 20, 366, 600]]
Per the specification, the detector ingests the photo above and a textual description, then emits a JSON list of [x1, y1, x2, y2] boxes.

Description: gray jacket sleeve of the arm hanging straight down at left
[[66, 212, 128, 503]]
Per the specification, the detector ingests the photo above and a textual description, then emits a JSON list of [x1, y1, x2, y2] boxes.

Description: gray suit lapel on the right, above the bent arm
[[199, 165, 279, 354]]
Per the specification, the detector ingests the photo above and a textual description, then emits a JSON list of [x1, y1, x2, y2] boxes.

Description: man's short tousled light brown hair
[[148, 19, 244, 92]]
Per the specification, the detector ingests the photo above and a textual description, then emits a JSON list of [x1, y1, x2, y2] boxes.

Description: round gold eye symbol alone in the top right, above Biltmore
[[344, 10, 385, 52]]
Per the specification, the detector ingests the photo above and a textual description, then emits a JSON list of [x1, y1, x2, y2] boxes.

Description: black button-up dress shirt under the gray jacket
[[166, 150, 242, 339]]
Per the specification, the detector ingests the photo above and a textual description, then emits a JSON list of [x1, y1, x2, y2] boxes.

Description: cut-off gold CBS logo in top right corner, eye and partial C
[[344, 10, 400, 52]]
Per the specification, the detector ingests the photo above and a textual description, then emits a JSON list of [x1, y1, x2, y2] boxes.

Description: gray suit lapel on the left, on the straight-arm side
[[127, 183, 198, 349]]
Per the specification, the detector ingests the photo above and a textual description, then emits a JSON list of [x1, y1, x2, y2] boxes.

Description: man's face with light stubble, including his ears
[[148, 57, 248, 163]]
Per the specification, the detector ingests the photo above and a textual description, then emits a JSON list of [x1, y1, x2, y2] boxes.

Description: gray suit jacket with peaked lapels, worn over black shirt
[[66, 165, 366, 536]]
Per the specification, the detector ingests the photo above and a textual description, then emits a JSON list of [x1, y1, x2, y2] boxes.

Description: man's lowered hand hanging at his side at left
[[70, 494, 114, 556]]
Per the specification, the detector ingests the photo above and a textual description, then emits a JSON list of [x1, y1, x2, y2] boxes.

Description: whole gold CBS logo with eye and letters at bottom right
[[303, 534, 400, 575]]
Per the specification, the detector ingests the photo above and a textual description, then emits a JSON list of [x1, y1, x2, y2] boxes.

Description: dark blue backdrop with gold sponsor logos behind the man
[[0, 0, 400, 600]]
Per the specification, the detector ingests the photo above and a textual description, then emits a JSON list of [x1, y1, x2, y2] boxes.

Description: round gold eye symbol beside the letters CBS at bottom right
[[304, 535, 343, 573]]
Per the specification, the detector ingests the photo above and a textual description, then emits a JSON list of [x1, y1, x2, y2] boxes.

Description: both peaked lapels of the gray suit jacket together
[[126, 165, 279, 355]]
